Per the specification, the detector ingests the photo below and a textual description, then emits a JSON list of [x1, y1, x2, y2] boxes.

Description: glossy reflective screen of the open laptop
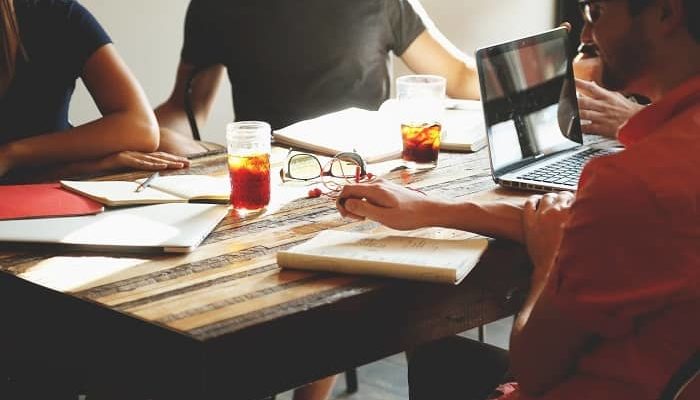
[[476, 28, 582, 176]]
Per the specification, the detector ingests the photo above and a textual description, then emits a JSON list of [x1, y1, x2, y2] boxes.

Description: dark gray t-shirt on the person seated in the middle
[[182, 0, 425, 128]]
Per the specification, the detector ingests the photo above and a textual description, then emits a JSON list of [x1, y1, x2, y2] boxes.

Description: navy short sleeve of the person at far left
[[65, 1, 112, 76]]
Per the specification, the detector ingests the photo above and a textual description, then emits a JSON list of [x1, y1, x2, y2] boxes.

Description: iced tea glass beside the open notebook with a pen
[[226, 121, 271, 213]]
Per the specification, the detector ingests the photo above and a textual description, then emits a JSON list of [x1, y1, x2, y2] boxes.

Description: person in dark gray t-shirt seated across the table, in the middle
[[156, 0, 479, 154]]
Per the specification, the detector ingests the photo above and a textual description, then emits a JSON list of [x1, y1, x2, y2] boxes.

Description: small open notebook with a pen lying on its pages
[[61, 175, 231, 207]]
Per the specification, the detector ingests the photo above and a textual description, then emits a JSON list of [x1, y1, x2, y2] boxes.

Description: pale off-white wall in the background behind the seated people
[[70, 0, 555, 143]]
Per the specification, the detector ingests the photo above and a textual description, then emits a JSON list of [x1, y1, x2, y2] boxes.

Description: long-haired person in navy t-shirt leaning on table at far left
[[0, 0, 188, 180]]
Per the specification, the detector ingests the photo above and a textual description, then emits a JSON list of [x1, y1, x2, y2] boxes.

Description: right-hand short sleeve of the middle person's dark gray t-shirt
[[385, 0, 425, 56]]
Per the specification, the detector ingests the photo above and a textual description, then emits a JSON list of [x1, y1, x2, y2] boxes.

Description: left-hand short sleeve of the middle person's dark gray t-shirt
[[180, 0, 221, 66]]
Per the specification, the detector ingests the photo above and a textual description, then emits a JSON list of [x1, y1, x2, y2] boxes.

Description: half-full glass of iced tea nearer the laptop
[[396, 75, 446, 169]]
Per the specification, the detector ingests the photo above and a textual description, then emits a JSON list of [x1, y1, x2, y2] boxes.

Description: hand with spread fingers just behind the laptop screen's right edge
[[576, 79, 644, 139]]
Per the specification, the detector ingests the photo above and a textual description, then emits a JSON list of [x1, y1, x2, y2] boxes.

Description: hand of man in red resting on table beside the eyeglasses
[[336, 179, 434, 230]]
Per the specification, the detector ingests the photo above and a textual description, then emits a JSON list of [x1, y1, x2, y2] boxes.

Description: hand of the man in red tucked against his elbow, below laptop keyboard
[[523, 192, 575, 279]]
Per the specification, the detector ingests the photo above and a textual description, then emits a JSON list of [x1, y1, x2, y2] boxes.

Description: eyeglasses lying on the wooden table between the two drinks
[[280, 150, 367, 181]]
